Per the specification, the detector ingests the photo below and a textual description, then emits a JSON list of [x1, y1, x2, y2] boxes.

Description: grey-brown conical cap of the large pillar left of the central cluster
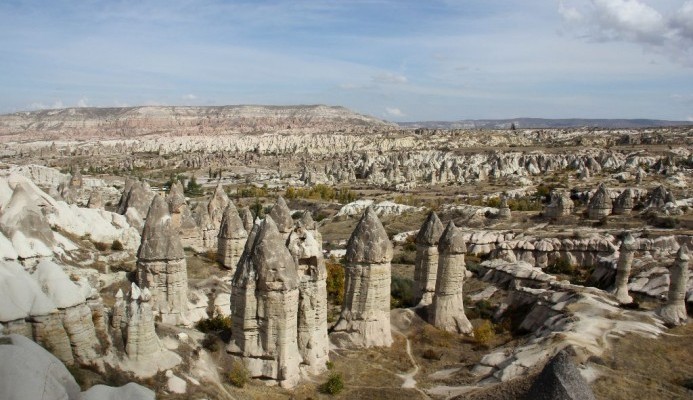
[[137, 195, 185, 261]]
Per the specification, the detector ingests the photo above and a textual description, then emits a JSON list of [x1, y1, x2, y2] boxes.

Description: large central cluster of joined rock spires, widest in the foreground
[[227, 197, 328, 387]]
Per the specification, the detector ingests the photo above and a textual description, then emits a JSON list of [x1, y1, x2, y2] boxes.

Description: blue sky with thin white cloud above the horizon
[[0, 0, 693, 122]]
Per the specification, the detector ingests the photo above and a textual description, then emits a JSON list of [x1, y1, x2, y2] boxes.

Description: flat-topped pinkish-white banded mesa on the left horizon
[[0, 105, 394, 140]]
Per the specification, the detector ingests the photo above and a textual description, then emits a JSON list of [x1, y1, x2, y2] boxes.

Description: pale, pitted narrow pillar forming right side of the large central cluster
[[288, 226, 329, 374]]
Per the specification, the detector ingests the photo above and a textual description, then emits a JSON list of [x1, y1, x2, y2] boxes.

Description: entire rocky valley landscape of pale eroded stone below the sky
[[0, 106, 693, 399]]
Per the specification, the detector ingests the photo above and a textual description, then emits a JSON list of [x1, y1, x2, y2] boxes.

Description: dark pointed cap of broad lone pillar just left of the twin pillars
[[346, 207, 393, 263]]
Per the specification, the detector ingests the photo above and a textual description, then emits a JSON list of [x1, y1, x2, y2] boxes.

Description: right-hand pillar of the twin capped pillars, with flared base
[[428, 221, 472, 334]]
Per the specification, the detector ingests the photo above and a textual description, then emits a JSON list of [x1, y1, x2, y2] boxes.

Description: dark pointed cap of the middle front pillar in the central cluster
[[251, 216, 298, 291]]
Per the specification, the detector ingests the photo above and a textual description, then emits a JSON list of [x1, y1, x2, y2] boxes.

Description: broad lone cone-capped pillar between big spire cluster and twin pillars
[[330, 207, 392, 348]]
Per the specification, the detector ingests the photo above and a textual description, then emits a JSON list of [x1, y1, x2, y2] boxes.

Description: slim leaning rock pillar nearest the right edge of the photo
[[657, 245, 690, 326]]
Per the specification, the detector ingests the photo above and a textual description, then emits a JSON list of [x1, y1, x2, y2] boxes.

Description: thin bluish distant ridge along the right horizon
[[398, 118, 693, 129]]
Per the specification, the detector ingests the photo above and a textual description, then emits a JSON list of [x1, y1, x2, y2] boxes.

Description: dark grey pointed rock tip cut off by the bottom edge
[[525, 350, 596, 400]]
